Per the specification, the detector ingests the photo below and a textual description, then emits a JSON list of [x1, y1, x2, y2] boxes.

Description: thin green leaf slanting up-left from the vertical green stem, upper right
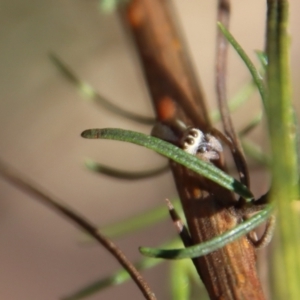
[[218, 22, 266, 103]]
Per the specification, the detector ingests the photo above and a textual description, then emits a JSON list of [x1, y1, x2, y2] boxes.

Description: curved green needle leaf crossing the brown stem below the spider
[[140, 205, 273, 259]]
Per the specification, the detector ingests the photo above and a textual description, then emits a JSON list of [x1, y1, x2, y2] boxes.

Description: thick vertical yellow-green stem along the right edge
[[266, 0, 300, 299]]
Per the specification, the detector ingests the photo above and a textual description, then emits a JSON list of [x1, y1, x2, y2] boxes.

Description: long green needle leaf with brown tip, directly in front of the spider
[[81, 128, 253, 201]]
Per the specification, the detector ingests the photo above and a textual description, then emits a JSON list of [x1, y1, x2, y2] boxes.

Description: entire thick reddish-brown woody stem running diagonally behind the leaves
[[121, 0, 264, 300]]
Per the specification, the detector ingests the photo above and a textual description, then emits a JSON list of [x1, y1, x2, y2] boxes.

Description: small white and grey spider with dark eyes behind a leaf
[[182, 128, 223, 161]]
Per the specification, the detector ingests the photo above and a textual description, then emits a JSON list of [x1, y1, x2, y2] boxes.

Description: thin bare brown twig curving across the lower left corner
[[0, 160, 156, 300]]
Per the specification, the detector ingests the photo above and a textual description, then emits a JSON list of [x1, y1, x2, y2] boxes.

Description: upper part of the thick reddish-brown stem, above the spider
[[117, 0, 211, 131]]
